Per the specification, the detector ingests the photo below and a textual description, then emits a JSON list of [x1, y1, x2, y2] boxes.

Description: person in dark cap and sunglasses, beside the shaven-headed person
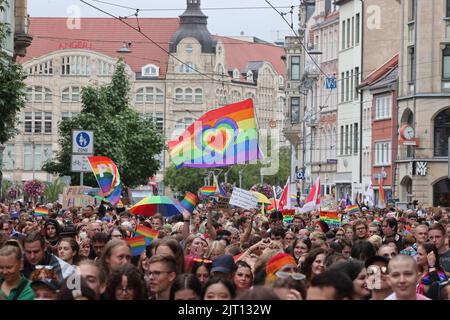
[[365, 256, 392, 300]]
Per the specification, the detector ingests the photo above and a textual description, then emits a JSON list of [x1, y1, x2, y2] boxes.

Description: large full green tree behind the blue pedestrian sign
[[44, 59, 163, 187]]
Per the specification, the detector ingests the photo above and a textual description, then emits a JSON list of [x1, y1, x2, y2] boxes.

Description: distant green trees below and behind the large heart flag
[[164, 148, 290, 194]]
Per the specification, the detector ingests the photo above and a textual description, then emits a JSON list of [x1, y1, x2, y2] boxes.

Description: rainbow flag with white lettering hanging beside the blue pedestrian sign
[[87, 156, 122, 206]]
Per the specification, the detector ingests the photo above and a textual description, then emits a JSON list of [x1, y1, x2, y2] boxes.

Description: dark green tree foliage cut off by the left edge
[[0, 0, 26, 144]]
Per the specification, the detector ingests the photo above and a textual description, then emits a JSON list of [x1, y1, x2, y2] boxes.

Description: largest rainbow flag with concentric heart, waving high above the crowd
[[168, 99, 263, 168]]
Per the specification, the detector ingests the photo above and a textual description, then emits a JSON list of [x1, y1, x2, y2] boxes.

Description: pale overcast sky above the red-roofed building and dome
[[28, 0, 300, 42]]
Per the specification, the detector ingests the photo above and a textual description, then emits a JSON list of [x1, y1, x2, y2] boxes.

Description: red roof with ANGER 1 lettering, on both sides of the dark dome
[[19, 17, 285, 79]]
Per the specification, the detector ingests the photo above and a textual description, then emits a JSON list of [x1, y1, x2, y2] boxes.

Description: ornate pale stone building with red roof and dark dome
[[4, 0, 285, 190]]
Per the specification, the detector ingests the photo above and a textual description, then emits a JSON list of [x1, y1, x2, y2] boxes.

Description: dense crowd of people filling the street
[[0, 202, 450, 300]]
